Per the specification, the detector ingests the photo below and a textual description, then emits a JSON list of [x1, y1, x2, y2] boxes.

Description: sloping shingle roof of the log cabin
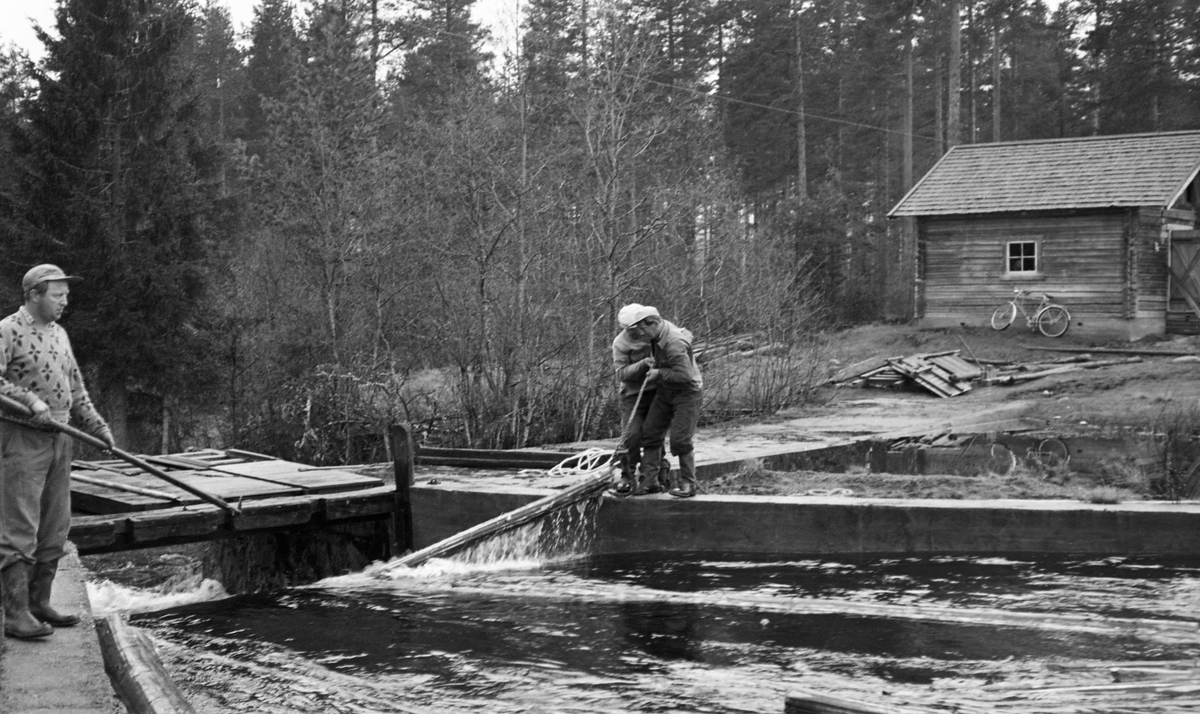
[[888, 131, 1200, 216]]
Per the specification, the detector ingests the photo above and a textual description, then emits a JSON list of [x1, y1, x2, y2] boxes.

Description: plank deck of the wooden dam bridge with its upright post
[[70, 426, 572, 558]]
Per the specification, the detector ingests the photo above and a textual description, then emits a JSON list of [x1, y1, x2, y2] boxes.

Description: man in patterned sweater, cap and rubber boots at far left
[[0, 265, 114, 638]]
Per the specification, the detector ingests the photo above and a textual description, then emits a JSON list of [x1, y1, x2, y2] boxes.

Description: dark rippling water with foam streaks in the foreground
[[117, 544, 1200, 713]]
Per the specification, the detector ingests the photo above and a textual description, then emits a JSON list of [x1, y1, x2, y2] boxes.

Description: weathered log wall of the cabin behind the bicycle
[[914, 206, 1195, 337]]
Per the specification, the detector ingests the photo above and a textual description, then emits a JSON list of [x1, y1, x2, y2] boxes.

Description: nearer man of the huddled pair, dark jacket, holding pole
[[626, 310, 704, 498]]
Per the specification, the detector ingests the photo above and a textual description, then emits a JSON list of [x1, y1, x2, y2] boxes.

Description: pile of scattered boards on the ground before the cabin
[[828, 349, 1142, 398]]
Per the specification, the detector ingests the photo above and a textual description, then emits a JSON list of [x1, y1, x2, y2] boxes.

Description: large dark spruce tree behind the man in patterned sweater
[[5, 0, 223, 438]]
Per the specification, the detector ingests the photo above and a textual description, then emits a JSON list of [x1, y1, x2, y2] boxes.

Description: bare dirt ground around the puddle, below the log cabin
[[706, 325, 1200, 502]]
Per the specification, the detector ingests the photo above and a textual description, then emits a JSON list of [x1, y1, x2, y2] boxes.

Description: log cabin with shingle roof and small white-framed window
[[888, 131, 1200, 340]]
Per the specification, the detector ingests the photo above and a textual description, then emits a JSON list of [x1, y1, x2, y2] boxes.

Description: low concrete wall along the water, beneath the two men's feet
[[413, 487, 1200, 556]]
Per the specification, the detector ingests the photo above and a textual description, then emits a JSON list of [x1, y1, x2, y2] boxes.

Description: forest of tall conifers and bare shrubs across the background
[[0, 0, 1200, 462]]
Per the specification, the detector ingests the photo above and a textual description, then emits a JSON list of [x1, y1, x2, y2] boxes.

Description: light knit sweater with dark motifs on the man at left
[[0, 307, 108, 436]]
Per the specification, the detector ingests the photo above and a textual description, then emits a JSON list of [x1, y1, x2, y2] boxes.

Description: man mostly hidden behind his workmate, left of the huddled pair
[[612, 302, 671, 496]]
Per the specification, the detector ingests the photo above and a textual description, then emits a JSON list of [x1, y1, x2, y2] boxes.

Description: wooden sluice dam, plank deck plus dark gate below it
[[70, 427, 590, 592]]
